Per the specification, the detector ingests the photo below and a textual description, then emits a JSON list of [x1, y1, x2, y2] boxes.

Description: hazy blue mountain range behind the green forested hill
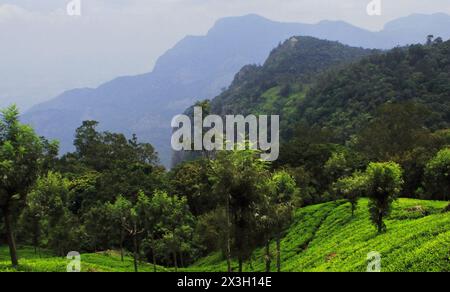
[[22, 14, 450, 166]]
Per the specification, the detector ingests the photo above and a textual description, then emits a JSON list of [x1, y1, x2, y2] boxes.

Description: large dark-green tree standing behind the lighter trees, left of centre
[[73, 121, 164, 207]]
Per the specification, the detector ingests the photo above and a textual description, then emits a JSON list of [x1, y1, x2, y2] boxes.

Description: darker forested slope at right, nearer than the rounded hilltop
[[298, 39, 450, 138]]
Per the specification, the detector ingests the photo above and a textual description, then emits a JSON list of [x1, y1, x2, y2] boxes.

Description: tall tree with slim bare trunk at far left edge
[[0, 106, 43, 267]]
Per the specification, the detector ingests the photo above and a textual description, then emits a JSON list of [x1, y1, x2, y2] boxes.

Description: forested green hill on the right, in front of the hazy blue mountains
[[211, 37, 450, 141]]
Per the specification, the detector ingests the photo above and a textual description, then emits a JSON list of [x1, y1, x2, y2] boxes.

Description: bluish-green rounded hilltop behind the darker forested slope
[[211, 36, 378, 115]]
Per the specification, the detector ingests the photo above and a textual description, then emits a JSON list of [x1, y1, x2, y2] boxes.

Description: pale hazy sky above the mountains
[[0, 0, 450, 106]]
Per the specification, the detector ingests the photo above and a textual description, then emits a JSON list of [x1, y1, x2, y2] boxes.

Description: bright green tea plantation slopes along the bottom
[[0, 199, 450, 272]]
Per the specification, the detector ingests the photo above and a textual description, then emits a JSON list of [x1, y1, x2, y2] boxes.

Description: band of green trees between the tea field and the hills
[[0, 104, 450, 272]]
